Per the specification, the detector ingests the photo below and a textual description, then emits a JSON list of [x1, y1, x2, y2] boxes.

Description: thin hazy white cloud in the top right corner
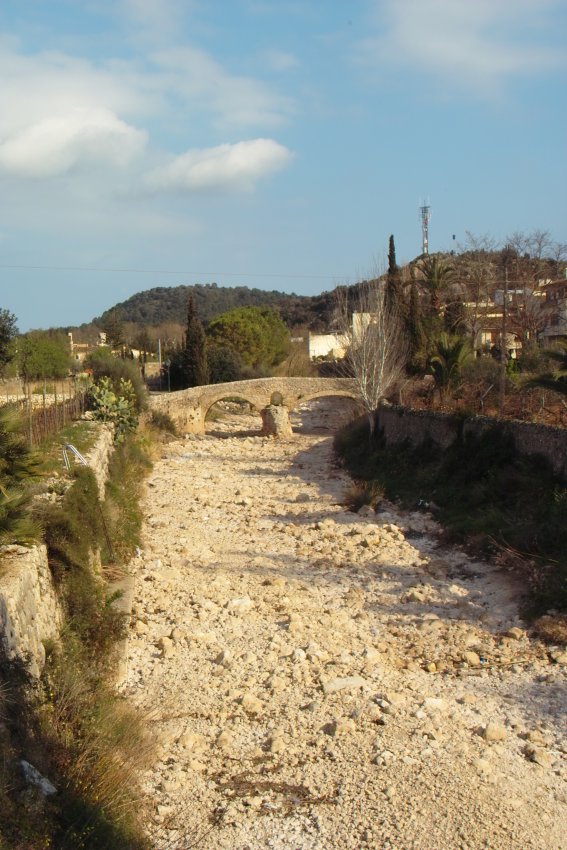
[[361, 0, 565, 91]]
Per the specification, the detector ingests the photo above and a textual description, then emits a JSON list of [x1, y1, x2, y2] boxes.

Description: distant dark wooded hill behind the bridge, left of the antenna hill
[[93, 283, 340, 330]]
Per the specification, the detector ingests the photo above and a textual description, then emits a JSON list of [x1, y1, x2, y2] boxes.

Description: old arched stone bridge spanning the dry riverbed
[[150, 377, 357, 434]]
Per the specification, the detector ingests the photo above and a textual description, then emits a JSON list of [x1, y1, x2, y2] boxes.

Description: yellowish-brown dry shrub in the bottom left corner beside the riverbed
[[42, 641, 155, 850]]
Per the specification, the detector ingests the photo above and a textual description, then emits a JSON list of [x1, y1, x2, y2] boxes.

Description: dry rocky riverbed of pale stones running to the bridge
[[124, 400, 567, 850]]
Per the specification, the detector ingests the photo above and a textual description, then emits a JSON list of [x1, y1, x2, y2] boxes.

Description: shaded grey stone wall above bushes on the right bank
[[376, 405, 567, 481]]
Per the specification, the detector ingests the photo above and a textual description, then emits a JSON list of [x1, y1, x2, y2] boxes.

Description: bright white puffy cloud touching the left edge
[[0, 108, 146, 177]]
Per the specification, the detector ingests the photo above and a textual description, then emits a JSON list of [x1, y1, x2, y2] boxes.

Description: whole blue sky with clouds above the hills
[[0, 0, 567, 332]]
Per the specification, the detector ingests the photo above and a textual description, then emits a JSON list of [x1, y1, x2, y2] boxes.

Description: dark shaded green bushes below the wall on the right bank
[[334, 417, 567, 614]]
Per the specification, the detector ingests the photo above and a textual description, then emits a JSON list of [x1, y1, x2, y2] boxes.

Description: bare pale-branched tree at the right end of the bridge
[[335, 280, 409, 434]]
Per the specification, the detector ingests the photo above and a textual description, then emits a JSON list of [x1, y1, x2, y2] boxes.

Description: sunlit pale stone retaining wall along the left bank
[[0, 424, 113, 676]]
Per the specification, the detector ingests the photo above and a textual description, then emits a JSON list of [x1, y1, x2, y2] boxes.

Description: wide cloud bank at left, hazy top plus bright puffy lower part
[[0, 36, 293, 181]]
